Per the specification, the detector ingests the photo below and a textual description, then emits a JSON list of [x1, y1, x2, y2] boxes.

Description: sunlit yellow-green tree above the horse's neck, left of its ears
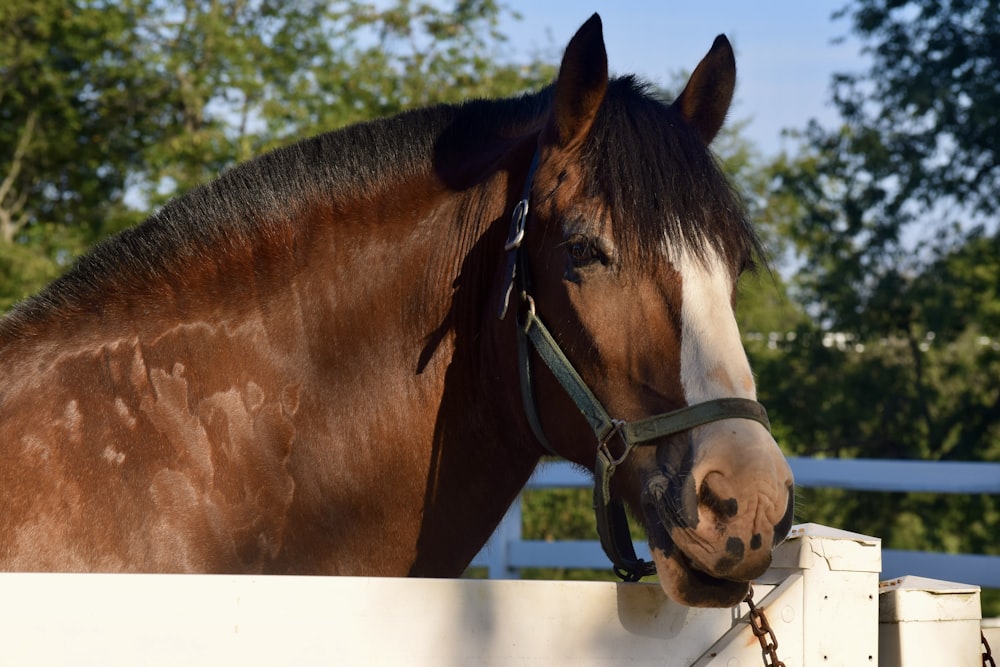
[[121, 0, 554, 205]]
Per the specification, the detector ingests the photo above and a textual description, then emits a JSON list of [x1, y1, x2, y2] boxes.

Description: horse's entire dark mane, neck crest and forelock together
[[0, 76, 760, 336]]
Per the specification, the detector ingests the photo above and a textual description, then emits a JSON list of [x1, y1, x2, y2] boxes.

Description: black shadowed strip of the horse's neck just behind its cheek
[[402, 170, 552, 576]]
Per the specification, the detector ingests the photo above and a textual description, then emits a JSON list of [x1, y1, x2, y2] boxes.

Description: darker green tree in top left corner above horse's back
[[0, 0, 173, 308]]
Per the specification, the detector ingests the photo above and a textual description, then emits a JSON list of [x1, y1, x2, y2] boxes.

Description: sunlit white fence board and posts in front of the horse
[[0, 524, 981, 667]]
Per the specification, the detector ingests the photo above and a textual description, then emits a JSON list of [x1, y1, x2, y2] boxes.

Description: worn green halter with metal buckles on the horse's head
[[498, 150, 771, 581]]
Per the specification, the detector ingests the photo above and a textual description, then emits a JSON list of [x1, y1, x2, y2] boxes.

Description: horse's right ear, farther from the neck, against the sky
[[673, 35, 736, 145]]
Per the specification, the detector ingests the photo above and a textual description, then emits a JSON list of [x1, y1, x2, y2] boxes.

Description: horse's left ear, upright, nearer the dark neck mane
[[545, 14, 608, 148]]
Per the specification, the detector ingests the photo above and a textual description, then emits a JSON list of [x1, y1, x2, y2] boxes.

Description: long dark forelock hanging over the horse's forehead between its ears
[[583, 76, 764, 277]]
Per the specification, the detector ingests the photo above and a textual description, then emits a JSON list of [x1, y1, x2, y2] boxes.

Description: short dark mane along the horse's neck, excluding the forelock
[[0, 89, 550, 336]]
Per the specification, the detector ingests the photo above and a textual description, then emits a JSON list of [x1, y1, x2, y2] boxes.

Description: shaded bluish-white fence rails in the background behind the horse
[[472, 457, 1000, 588]]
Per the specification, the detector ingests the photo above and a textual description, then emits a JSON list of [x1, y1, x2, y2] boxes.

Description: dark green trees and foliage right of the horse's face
[[750, 0, 1000, 613]]
